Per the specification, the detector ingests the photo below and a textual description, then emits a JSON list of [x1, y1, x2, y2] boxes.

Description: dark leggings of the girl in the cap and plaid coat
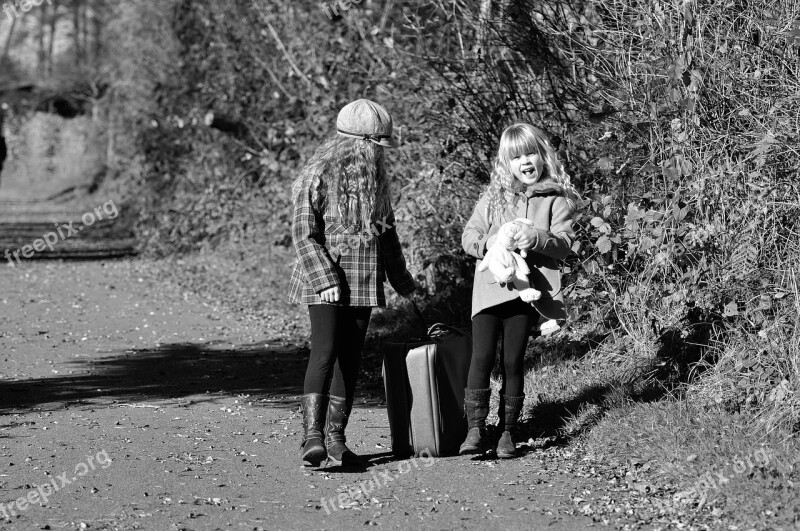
[[303, 304, 372, 401]]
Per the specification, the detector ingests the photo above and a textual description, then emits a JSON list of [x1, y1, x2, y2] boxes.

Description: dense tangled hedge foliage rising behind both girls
[[101, 0, 800, 430]]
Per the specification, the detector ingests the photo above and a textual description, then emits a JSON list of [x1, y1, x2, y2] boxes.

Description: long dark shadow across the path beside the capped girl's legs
[[0, 343, 383, 414]]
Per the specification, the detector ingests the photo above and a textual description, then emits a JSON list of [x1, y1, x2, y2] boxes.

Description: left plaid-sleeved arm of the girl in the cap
[[292, 181, 339, 293]]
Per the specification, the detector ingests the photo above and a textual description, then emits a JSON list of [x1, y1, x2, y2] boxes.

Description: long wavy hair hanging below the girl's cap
[[292, 135, 390, 231]]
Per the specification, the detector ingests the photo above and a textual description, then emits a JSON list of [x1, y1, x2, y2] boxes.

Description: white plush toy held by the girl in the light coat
[[478, 218, 560, 335]]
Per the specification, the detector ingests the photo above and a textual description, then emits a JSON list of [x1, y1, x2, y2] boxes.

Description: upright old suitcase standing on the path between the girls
[[383, 324, 472, 458]]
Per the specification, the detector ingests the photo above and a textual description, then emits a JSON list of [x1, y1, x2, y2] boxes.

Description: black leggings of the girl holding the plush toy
[[467, 299, 539, 396]]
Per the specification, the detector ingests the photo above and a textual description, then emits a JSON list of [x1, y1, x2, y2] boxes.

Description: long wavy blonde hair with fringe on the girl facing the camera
[[486, 122, 580, 220]]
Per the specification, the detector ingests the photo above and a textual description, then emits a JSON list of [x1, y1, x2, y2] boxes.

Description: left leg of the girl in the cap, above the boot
[[303, 304, 344, 395]]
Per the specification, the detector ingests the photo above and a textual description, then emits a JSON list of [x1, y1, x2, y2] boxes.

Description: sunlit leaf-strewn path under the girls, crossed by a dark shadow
[[0, 260, 612, 529]]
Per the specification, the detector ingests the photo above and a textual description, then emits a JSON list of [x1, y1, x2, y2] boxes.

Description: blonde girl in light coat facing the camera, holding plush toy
[[460, 123, 580, 458]]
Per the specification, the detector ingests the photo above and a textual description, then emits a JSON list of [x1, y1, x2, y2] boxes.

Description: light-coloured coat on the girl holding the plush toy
[[461, 181, 575, 320]]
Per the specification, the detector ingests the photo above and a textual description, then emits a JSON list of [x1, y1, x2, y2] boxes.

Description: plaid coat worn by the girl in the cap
[[289, 172, 416, 306]]
